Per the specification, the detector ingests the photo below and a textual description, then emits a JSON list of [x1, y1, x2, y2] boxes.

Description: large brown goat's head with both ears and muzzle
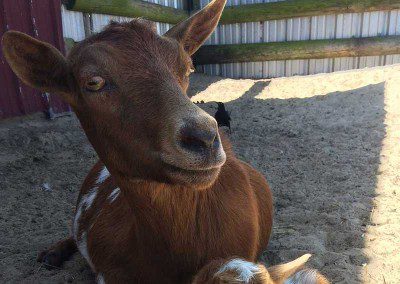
[[3, 0, 226, 188]]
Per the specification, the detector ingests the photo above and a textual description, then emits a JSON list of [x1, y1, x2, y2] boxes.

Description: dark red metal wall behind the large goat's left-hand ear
[[0, 0, 69, 118]]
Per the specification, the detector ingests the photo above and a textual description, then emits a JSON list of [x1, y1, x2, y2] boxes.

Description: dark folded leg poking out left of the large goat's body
[[37, 237, 78, 268]]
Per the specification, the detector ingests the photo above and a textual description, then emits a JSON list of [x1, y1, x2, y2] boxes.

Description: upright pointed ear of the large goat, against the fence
[[165, 0, 226, 55]]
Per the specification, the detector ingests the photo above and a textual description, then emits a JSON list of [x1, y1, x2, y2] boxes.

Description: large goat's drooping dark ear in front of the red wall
[[2, 31, 71, 103]]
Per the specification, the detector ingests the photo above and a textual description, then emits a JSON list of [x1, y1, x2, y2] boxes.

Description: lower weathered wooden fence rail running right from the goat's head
[[194, 36, 400, 64]]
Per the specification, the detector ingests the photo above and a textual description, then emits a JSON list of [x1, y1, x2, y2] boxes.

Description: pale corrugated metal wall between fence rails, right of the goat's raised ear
[[198, 0, 400, 78]]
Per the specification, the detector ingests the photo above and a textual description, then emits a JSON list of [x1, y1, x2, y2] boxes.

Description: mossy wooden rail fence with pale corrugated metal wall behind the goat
[[63, 0, 400, 78]]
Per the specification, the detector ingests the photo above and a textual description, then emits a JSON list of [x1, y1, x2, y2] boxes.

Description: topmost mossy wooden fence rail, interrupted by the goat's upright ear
[[64, 0, 400, 24]]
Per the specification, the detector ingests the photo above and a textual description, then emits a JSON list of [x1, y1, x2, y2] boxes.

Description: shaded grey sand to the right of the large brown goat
[[202, 81, 385, 283]]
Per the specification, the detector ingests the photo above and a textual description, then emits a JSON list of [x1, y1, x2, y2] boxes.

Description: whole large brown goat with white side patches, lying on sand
[[2, 0, 328, 283]]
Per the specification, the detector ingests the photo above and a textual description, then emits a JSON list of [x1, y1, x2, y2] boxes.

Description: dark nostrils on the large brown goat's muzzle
[[180, 127, 219, 151]]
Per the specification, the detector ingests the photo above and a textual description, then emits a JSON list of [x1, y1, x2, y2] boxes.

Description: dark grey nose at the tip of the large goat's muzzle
[[180, 123, 220, 152]]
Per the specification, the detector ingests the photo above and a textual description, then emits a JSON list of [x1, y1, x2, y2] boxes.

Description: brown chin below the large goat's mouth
[[162, 165, 221, 190]]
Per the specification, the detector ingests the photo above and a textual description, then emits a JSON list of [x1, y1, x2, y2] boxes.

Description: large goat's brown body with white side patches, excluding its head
[[74, 136, 272, 283]]
